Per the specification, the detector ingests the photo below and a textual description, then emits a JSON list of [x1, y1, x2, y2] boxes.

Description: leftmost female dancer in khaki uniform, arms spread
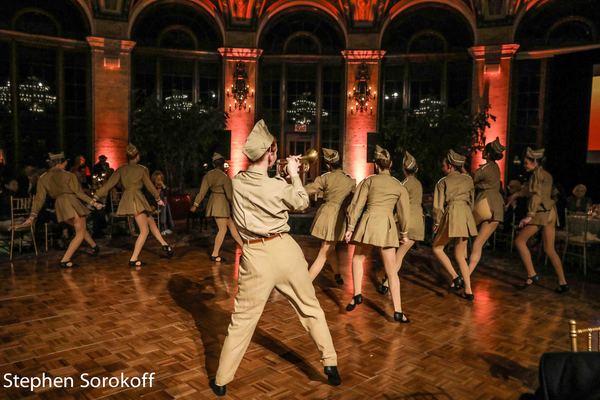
[[24, 153, 103, 268]]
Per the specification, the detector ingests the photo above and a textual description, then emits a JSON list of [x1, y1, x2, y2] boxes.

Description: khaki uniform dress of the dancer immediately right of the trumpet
[[305, 169, 356, 242]]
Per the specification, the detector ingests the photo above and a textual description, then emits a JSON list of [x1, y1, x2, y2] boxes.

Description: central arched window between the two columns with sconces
[[258, 9, 345, 174]]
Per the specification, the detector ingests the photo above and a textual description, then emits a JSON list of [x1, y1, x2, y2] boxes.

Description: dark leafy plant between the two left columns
[[131, 96, 228, 189]]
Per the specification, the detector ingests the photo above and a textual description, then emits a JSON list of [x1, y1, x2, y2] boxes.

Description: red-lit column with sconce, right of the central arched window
[[342, 50, 385, 182]]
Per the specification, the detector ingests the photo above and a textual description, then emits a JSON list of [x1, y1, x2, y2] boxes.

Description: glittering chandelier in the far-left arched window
[[0, 75, 56, 113]]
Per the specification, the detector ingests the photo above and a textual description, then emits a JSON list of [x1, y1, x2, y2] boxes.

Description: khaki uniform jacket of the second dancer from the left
[[95, 163, 160, 215]]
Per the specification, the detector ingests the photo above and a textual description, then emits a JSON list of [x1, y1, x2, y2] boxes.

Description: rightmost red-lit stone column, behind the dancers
[[469, 44, 519, 181]]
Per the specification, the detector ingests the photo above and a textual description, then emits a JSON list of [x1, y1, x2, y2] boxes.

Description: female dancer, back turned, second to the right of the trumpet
[[345, 146, 410, 323]]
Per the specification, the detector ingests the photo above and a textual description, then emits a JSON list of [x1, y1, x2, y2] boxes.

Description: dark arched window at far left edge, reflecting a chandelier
[[0, 0, 92, 166]]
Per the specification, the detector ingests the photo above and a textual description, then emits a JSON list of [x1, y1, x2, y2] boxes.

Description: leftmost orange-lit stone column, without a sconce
[[87, 36, 135, 168]]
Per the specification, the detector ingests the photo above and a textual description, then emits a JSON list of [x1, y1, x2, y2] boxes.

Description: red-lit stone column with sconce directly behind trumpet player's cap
[[219, 47, 262, 176]]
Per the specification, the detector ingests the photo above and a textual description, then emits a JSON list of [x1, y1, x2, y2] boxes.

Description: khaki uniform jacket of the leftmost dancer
[[31, 168, 93, 222]]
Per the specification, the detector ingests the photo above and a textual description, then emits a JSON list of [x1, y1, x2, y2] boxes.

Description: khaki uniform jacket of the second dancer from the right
[[473, 161, 504, 222]]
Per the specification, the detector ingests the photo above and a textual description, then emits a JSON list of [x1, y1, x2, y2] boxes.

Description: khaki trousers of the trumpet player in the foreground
[[215, 234, 337, 386]]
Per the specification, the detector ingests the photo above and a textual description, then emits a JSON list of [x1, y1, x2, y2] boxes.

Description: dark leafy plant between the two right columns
[[382, 105, 496, 191]]
